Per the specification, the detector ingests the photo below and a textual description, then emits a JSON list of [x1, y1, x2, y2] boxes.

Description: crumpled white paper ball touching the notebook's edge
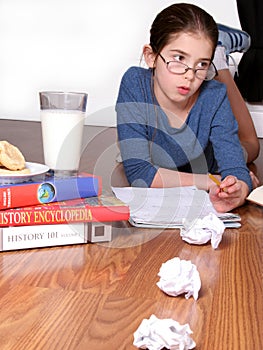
[[180, 213, 225, 249]]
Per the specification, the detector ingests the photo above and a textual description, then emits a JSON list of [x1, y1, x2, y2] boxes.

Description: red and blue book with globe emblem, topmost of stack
[[0, 173, 102, 210]]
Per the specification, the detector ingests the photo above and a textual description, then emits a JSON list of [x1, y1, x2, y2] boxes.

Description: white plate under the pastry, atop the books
[[0, 162, 49, 185]]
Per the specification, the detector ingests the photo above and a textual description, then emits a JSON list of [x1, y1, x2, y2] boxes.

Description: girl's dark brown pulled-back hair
[[150, 3, 218, 58]]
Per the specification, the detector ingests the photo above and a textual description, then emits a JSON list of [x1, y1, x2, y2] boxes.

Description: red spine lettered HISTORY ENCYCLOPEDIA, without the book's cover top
[[0, 203, 130, 227]]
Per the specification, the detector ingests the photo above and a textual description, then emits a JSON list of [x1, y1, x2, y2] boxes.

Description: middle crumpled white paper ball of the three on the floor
[[157, 257, 201, 300]]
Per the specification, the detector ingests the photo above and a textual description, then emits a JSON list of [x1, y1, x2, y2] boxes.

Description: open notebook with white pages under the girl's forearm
[[112, 186, 241, 228]]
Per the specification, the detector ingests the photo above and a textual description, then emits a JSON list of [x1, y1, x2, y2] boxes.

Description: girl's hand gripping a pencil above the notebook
[[209, 175, 249, 212]]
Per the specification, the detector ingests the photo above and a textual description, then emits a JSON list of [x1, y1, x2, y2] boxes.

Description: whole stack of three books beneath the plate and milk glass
[[0, 173, 130, 251]]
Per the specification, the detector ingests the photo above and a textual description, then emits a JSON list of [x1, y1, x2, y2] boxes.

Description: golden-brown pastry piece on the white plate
[[0, 141, 26, 170]]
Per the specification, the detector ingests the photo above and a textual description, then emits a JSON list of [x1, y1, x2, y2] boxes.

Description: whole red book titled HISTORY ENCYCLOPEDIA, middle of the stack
[[0, 196, 130, 227]]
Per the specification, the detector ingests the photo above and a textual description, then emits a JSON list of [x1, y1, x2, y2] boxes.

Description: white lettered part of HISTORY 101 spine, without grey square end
[[0, 223, 88, 251]]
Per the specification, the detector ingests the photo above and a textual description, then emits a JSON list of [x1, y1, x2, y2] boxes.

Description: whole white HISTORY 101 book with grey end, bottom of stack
[[0, 222, 112, 251]]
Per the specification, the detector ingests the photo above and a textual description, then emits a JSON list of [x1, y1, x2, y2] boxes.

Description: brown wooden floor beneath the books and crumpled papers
[[0, 120, 263, 350]]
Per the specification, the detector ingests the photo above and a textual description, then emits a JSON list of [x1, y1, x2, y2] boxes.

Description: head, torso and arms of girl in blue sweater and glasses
[[116, 3, 252, 212]]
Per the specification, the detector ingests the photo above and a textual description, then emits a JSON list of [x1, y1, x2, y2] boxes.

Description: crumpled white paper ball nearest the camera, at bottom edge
[[133, 315, 196, 350]]
